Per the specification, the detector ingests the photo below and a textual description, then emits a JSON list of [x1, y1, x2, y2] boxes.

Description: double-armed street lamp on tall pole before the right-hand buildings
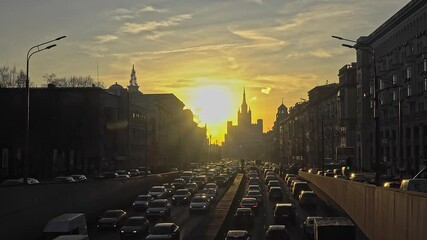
[[332, 36, 381, 186]]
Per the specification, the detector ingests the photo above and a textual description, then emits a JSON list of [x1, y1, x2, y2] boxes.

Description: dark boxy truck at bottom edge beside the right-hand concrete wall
[[314, 217, 356, 240]]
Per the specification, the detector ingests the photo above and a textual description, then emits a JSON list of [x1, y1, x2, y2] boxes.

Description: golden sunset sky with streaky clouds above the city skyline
[[0, 0, 409, 143]]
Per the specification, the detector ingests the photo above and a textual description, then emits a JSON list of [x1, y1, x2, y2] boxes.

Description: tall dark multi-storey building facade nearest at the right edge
[[356, 0, 427, 175]]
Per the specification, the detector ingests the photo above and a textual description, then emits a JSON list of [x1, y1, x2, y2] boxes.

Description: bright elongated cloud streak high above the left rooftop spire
[[120, 14, 192, 34]]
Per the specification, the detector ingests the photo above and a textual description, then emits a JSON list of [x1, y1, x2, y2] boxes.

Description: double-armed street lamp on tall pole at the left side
[[23, 36, 66, 184]]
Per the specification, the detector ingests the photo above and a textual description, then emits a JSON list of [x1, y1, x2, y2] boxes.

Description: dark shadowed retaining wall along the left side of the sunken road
[[0, 172, 178, 240]]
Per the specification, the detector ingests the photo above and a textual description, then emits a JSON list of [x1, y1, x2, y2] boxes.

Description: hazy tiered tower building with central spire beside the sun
[[223, 89, 265, 160]]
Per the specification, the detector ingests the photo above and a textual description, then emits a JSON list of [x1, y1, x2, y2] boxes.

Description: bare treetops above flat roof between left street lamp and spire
[[43, 73, 105, 88]]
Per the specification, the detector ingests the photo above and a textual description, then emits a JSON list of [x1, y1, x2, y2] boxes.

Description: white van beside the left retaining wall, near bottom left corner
[[43, 213, 87, 240]]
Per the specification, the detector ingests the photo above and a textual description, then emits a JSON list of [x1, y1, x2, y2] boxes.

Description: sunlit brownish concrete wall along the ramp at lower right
[[299, 172, 427, 240]]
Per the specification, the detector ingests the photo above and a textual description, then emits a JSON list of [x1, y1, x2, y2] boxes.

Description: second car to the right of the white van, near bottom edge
[[120, 216, 150, 239]]
